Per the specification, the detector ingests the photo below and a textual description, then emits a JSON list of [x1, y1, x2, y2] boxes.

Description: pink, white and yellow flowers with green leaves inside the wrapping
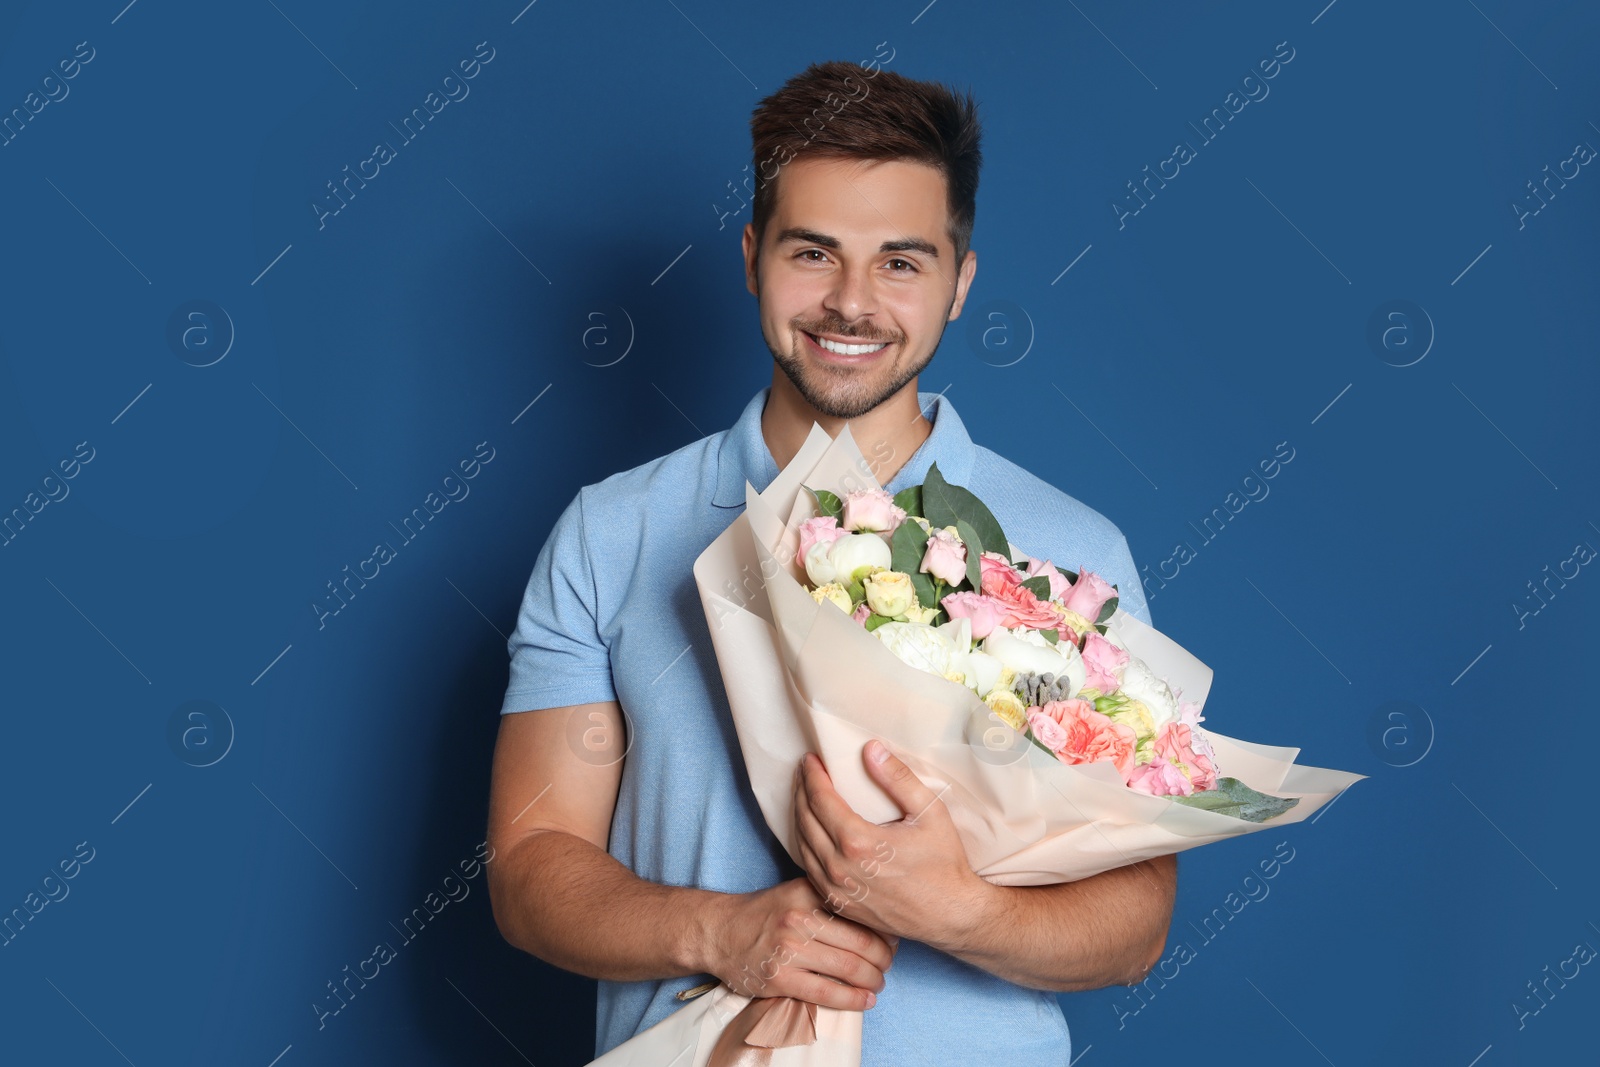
[[795, 464, 1299, 822]]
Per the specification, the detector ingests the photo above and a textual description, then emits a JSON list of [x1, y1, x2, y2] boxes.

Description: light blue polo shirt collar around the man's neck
[[710, 386, 976, 507]]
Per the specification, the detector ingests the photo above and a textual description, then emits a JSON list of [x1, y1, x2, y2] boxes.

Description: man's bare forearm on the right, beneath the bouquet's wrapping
[[936, 856, 1178, 992]]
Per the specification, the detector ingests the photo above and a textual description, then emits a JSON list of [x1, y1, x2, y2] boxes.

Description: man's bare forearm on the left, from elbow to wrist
[[490, 830, 730, 982]]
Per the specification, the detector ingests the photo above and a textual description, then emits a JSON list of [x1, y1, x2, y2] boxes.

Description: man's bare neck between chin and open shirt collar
[[762, 366, 933, 485]]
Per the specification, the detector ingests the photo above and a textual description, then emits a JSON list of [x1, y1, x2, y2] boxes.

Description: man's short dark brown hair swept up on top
[[750, 61, 982, 266]]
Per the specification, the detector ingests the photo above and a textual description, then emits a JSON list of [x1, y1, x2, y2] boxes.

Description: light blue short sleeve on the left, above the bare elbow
[[501, 491, 616, 715]]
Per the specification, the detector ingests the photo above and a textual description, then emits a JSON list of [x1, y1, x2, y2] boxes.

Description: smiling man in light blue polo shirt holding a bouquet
[[490, 62, 1176, 1065]]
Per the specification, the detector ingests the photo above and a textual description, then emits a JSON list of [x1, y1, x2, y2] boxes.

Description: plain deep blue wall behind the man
[[0, 0, 1600, 1067]]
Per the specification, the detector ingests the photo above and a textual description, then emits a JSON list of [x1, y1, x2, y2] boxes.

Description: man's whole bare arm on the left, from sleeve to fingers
[[486, 701, 894, 1011]]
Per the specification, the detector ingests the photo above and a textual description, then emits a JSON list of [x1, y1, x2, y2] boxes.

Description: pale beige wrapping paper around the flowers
[[595, 424, 1365, 1067]]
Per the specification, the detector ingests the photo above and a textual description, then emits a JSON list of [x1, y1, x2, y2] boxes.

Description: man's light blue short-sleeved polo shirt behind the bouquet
[[501, 389, 1150, 1067]]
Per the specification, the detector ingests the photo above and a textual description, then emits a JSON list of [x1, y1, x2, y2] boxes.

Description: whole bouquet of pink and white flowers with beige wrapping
[[595, 426, 1363, 1067]]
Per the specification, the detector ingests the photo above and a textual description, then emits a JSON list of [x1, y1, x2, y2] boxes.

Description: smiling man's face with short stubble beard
[[744, 158, 978, 419]]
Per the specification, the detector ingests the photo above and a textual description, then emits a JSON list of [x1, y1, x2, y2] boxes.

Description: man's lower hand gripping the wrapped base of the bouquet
[[706, 878, 896, 1011]]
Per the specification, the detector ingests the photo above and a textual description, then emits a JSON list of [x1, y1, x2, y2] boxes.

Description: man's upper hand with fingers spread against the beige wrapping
[[794, 741, 995, 949]]
